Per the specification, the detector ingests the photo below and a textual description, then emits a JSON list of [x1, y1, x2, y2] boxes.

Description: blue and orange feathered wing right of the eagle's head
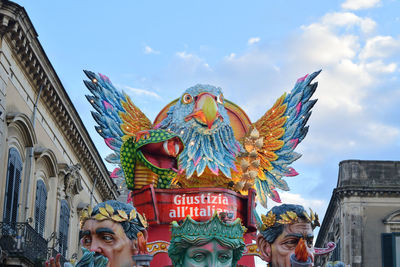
[[254, 71, 321, 207]]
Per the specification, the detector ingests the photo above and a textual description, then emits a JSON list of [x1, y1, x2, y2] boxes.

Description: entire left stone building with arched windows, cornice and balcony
[[0, 0, 118, 266]]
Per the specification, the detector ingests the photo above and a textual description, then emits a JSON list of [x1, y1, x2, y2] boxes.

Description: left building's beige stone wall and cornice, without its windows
[[0, 1, 118, 261]]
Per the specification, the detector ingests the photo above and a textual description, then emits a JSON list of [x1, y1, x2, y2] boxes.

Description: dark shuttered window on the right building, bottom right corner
[[382, 233, 400, 267]]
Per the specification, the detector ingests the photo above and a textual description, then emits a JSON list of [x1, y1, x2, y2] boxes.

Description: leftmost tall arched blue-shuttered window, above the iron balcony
[[3, 147, 22, 229]]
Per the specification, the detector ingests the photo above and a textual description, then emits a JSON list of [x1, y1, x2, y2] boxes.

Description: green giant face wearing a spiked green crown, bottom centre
[[168, 214, 246, 267]]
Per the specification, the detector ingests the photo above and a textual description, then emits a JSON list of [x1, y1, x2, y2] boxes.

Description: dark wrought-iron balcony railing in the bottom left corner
[[0, 222, 66, 266]]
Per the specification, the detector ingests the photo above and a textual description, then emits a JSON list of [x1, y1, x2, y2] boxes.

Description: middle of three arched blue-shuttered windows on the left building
[[35, 180, 47, 236]]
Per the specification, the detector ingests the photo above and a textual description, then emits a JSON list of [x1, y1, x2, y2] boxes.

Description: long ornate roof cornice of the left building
[[0, 0, 118, 199]]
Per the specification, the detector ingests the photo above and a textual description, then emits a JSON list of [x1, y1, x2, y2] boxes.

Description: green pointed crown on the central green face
[[171, 213, 247, 240]]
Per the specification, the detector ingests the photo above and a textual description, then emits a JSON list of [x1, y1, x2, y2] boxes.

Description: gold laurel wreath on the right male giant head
[[260, 209, 320, 231]]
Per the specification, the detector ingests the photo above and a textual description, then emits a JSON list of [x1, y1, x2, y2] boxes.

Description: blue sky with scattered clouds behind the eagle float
[[16, 0, 400, 264]]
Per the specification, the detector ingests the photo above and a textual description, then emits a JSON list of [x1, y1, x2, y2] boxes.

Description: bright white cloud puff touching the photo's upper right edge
[[359, 35, 400, 60]]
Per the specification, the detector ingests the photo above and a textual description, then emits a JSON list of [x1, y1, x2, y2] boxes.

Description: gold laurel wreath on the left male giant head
[[80, 203, 148, 228]]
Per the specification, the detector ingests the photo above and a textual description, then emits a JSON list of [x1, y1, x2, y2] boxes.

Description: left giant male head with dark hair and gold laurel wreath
[[46, 200, 147, 267]]
